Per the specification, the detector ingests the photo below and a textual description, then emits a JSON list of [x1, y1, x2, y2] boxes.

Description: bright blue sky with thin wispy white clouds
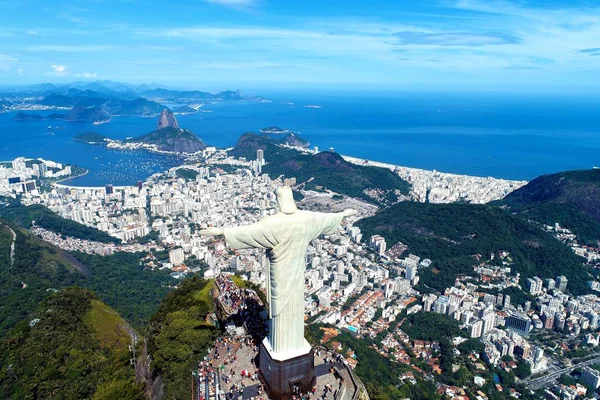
[[0, 0, 600, 92]]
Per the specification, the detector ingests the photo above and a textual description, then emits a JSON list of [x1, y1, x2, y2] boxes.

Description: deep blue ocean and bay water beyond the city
[[0, 93, 600, 186]]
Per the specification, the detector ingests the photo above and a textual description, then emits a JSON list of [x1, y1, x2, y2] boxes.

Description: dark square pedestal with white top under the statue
[[258, 338, 316, 400]]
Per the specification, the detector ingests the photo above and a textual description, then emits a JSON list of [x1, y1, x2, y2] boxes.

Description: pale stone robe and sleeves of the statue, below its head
[[223, 210, 344, 355]]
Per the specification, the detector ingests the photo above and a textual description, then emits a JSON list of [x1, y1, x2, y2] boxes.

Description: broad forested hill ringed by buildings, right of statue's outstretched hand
[[358, 202, 589, 294]]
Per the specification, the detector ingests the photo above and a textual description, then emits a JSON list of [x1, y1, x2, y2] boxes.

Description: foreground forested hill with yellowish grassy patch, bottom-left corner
[[0, 287, 145, 400]]
